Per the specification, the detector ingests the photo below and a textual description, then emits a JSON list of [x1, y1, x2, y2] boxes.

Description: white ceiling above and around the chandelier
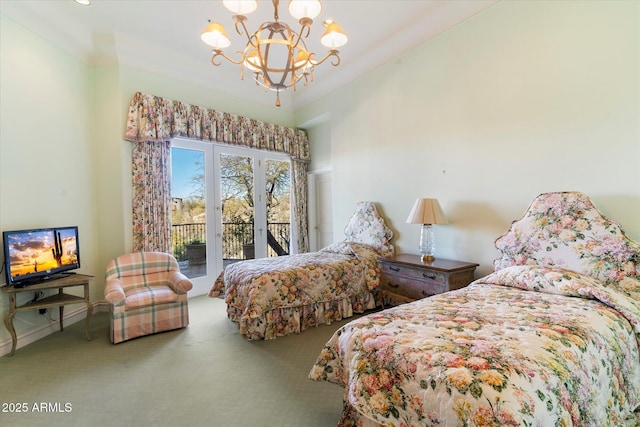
[[0, 0, 498, 111]]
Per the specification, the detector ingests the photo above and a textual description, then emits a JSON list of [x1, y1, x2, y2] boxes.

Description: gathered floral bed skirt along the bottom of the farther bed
[[227, 292, 376, 340]]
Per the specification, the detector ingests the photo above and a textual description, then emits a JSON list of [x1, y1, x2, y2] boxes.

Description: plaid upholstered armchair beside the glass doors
[[104, 252, 193, 344]]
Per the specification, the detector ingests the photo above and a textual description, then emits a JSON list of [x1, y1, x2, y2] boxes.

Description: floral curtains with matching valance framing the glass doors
[[125, 92, 310, 252]]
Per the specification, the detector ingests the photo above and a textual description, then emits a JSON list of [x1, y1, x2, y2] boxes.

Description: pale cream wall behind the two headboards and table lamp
[[297, 1, 640, 274]]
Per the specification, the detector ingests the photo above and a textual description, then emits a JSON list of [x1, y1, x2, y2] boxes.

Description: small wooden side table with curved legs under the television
[[2, 274, 93, 356]]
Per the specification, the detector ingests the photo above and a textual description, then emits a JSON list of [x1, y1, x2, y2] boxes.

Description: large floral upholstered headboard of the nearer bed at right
[[494, 191, 640, 288]]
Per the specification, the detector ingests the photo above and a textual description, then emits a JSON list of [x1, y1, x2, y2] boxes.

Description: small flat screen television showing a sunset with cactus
[[2, 226, 80, 287]]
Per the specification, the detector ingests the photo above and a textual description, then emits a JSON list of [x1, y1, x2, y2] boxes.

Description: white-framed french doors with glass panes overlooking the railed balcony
[[171, 139, 295, 295]]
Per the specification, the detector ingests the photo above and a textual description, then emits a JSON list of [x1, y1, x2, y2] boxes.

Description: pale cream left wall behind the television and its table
[[0, 16, 100, 340]]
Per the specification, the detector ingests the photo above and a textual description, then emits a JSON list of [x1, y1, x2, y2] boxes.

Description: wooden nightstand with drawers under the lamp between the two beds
[[378, 254, 479, 306]]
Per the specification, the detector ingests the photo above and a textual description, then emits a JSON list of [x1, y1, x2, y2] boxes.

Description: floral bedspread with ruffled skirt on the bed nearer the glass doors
[[209, 242, 380, 339]]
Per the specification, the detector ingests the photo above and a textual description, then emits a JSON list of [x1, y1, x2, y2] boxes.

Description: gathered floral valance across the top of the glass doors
[[125, 92, 310, 162]]
